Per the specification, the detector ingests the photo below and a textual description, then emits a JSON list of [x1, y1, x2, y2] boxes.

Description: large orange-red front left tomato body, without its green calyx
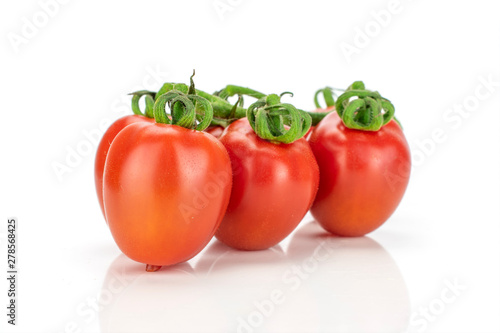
[[103, 123, 232, 266]]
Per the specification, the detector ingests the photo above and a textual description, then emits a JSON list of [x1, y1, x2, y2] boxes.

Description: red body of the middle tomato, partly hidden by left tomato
[[215, 118, 319, 250]]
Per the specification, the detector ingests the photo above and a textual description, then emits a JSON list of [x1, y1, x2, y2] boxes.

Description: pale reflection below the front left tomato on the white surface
[[98, 254, 204, 333]]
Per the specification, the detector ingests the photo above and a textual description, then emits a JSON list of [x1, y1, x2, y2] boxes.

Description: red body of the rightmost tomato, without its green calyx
[[309, 112, 411, 237]]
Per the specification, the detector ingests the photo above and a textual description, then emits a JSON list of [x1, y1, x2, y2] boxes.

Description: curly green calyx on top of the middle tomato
[[246, 94, 311, 143]]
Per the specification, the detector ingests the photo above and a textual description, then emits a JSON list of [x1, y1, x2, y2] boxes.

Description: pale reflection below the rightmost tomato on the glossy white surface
[[281, 222, 411, 332]]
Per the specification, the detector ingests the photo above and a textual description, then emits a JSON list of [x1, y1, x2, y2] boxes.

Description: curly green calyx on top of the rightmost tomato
[[335, 81, 394, 131]]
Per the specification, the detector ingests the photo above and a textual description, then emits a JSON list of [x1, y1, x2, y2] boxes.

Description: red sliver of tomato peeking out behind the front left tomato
[[94, 115, 154, 219]]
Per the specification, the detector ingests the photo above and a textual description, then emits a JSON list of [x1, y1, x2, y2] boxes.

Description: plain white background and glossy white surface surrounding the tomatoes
[[0, 0, 500, 332]]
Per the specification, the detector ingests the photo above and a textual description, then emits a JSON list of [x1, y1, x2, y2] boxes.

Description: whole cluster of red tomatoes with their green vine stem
[[95, 76, 410, 271]]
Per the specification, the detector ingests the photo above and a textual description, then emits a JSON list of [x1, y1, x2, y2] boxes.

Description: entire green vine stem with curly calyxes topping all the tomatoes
[[131, 71, 399, 134]]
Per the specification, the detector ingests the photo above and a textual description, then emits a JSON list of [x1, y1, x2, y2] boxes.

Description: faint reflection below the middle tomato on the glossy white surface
[[193, 242, 292, 333]]
